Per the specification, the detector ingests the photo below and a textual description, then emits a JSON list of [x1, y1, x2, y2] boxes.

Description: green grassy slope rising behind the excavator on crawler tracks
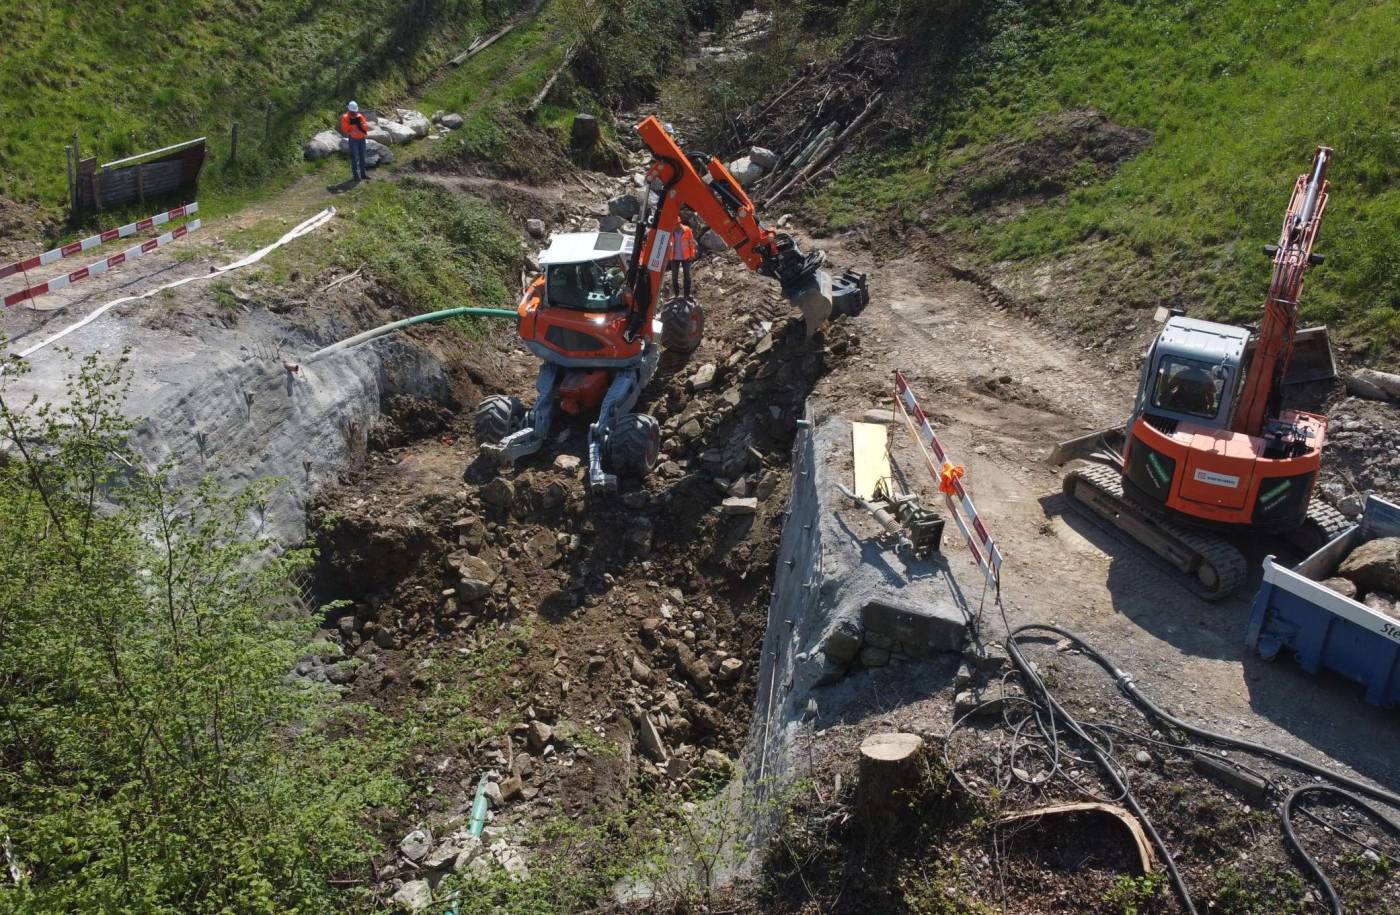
[[812, 0, 1400, 366]]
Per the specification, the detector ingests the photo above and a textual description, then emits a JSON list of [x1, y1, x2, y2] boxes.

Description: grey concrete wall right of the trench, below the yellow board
[[745, 403, 969, 845]]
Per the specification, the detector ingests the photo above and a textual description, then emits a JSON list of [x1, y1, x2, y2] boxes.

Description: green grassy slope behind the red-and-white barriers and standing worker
[[0, 0, 518, 208]]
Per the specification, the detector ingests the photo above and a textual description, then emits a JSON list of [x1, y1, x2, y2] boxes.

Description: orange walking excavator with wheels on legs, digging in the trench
[[475, 118, 869, 492]]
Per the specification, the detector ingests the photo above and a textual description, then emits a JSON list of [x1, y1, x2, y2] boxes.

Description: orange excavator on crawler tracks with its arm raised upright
[[1050, 147, 1347, 600]]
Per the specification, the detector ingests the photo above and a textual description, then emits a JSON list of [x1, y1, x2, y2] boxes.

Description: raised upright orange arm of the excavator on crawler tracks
[[1235, 146, 1331, 435]]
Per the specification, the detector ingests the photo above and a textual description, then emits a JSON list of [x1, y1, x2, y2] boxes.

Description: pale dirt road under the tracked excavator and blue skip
[[795, 241, 1400, 785]]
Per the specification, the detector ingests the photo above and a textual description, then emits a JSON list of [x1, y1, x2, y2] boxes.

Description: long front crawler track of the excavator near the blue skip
[[1064, 463, 1249, 602]]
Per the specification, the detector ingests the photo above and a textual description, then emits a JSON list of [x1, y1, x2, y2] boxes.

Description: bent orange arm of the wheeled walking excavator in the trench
[[627, 118, 832, 337]]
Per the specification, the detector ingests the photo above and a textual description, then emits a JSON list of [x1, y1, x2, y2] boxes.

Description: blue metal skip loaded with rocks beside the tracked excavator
[[1246, 495, 1400, 708]]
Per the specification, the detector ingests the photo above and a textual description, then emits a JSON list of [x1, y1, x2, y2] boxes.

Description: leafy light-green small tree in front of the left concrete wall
[[0, 358, 395, 912]]
